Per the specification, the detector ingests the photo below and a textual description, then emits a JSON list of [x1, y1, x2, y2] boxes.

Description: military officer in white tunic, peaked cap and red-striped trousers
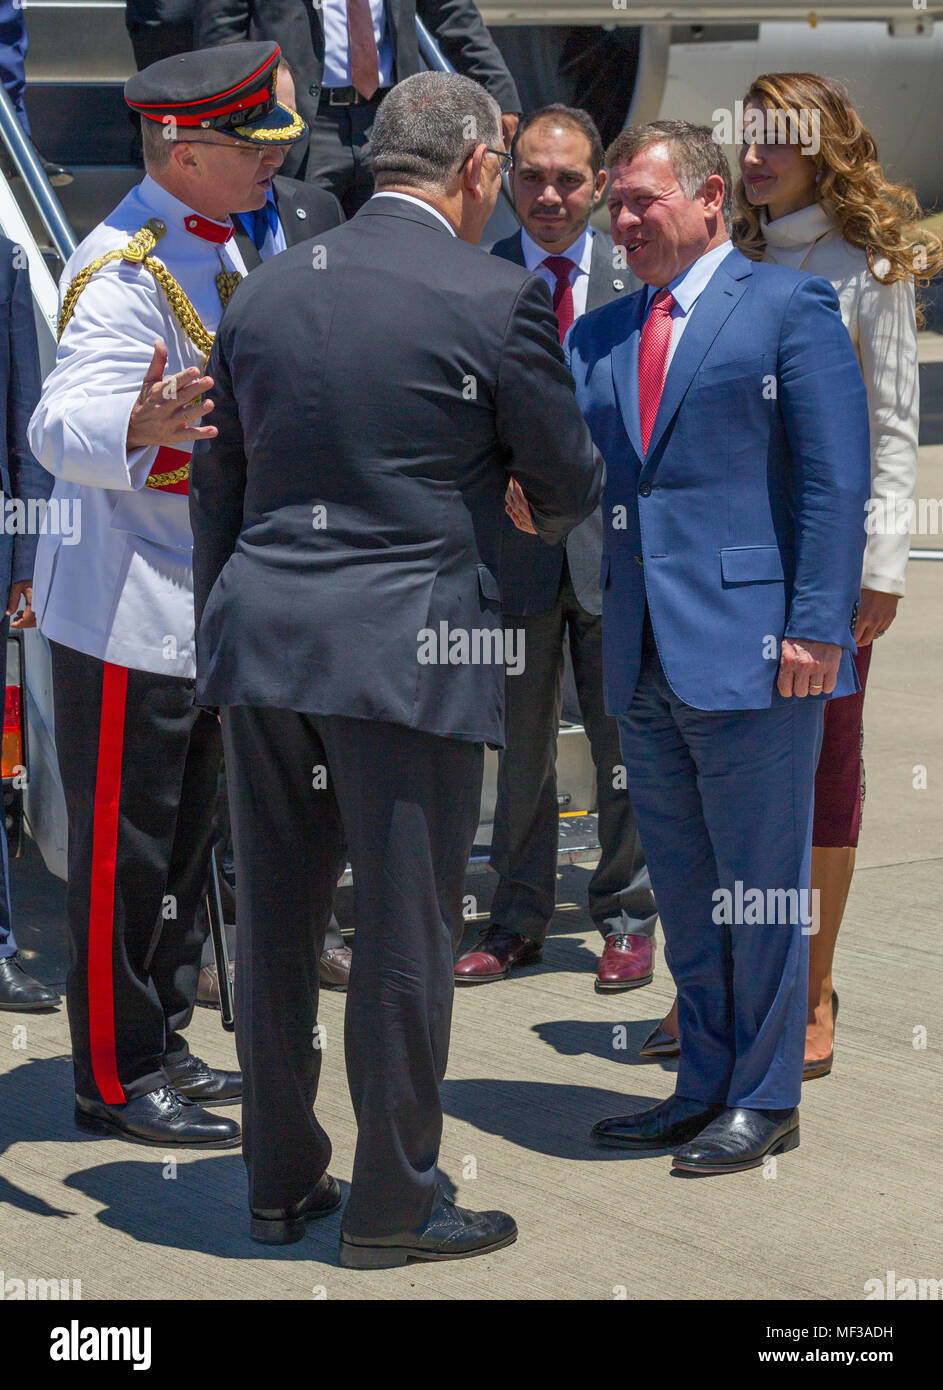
[[29, 43, 307, 1147]]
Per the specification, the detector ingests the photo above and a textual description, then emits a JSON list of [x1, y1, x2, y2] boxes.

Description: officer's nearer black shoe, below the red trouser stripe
[[75, 1086, 242, 1148]]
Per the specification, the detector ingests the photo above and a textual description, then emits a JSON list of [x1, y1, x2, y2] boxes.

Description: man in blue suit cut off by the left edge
[[0, 236, 58, 1011]]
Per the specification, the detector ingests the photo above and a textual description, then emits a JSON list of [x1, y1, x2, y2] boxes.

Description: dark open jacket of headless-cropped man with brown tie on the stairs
[[195, 0, 520, 138]]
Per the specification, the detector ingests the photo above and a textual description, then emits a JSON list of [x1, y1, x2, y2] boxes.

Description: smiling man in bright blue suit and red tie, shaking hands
[[567, 121, 869, 1173]]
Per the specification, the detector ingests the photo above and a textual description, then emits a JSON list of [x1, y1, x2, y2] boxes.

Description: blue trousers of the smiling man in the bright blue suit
[[619, 621, 825, 1109]]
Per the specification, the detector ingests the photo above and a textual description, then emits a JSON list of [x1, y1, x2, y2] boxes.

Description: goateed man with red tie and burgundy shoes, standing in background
[[455, 104, 655, 991]]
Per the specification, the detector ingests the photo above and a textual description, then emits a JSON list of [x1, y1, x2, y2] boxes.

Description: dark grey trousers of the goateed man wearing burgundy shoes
[[491, 562, 656, 941]]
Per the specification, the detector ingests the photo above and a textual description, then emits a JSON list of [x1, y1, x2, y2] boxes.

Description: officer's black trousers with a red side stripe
[[50, 642, 221, 1105]]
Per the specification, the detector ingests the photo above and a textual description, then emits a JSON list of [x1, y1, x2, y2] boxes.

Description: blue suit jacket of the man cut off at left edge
[[0, 236, 56, 594]]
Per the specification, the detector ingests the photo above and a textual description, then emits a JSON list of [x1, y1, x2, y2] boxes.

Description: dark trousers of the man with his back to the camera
[[223, 708, 484, 1236]]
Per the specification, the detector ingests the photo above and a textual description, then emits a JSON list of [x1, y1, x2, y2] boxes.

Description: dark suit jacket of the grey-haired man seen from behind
[[191, 197, 602, 744]]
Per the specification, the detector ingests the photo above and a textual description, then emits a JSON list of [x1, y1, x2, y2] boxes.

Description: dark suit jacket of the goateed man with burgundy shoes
[[491, 228, 638, 616]]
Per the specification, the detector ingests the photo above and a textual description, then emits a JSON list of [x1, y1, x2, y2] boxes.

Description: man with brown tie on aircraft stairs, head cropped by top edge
[[195, 0, 520, 217]]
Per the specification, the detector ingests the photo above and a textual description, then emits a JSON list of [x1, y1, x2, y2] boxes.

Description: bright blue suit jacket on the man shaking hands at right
[[566, 250, 871, 714]]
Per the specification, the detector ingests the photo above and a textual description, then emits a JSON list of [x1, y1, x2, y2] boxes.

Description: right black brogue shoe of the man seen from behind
[[341, 1197, 517, 1269]]
